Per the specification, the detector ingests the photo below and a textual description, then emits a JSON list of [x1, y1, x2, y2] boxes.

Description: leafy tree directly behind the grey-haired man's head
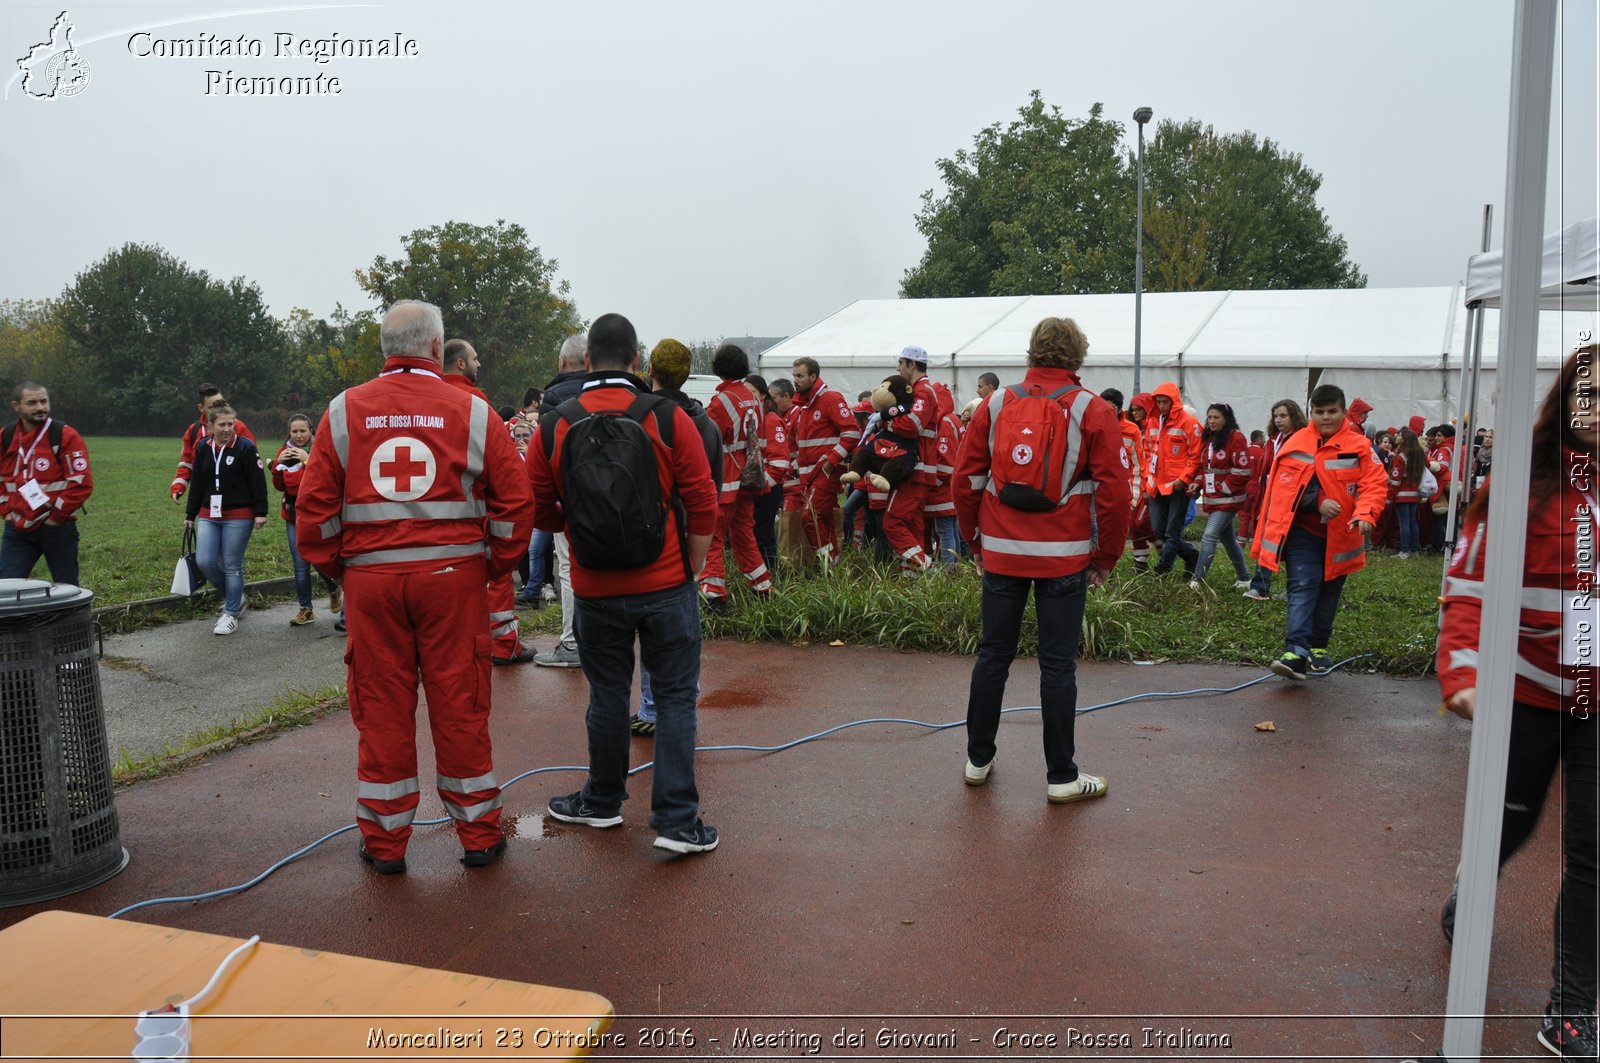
[[355, 219, 584, 402]]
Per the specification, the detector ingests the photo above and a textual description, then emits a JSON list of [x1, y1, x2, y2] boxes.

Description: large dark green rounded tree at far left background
[[54, 243, 283, 434]]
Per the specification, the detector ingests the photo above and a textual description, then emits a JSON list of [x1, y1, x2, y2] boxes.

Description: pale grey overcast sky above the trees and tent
[[0, 0, 1600, 357]]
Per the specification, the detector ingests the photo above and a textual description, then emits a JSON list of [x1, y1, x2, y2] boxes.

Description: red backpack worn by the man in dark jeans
[[989, 384, 1085, 512]]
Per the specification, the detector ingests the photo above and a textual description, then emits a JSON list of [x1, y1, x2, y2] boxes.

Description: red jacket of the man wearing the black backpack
[[525, 371, 716, 599]]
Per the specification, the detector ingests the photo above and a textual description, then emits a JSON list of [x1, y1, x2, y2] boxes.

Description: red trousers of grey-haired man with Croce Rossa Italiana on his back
[[344, 559, 502, 860]]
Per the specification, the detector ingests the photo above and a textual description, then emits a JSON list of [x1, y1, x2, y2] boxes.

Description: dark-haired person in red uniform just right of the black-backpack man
[[701, 343, 773, 613]]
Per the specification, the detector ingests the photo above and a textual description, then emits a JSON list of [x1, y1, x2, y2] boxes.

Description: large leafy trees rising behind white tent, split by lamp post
[[901, 91, 1366, 298]]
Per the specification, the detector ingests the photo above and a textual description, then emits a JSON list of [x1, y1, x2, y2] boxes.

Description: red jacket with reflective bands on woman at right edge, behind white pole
[[1435, 448, 1600, 704]]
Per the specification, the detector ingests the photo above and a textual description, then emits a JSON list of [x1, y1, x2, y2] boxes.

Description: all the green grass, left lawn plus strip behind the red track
[[62, 437, 1442, 676]]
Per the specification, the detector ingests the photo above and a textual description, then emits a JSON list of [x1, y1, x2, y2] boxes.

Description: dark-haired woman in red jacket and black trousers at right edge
[[1437, 344, 1600, 1058]]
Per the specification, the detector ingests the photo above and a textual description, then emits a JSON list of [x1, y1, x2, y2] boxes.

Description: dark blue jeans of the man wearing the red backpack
[[966, 572, 1088, 783]]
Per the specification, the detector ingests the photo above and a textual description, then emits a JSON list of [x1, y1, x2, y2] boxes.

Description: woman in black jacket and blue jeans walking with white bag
[[184, 403, 267, 636]]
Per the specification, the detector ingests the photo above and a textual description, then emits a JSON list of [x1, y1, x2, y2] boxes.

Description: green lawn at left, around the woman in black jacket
[[77, 435, 294, 605]]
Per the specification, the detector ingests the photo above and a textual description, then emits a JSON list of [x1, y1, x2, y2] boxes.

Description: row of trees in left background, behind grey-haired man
[[0, 221, 586, 435]]
